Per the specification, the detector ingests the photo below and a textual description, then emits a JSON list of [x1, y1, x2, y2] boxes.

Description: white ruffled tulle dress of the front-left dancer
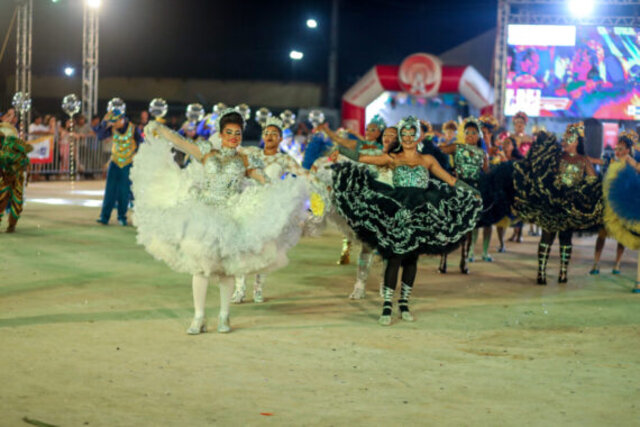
[[131, 132, 307, 276]]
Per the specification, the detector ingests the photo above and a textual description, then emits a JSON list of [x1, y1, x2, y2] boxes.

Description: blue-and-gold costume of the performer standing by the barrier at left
[[97, 118, 143, 226]]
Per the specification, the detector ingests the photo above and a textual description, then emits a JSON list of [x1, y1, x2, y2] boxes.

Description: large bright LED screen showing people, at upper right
[[505, 25, 640, 120]]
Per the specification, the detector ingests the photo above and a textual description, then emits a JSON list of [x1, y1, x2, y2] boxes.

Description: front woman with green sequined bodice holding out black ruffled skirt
[[333, 117, 482, 325]]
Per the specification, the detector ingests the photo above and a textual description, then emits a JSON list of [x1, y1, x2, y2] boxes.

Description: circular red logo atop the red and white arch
[[398, 53, 442, 96]]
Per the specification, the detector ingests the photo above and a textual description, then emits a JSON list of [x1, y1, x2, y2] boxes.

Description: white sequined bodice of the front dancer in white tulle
[[198, 148, 246, 203]]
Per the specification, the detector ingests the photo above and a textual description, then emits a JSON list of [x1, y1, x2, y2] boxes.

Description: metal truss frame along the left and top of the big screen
[[493, 0, 640, 121]]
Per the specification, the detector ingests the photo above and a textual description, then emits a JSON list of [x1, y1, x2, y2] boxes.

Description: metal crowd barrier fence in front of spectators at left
[[29, 135, 111, 181]]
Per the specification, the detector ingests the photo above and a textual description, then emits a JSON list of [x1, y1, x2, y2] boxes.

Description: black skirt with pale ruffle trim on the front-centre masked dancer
[[333, 162, 482, 258]]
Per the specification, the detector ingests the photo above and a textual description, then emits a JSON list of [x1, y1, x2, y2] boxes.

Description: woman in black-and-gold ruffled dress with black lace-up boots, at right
[[513, 123, 604, 285]]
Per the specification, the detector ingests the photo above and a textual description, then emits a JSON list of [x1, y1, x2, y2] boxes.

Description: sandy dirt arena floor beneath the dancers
[[0, 182, 640, 426]]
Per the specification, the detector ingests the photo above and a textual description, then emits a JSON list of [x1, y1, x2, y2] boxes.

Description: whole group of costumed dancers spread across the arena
[[0, 109, 640, 334]]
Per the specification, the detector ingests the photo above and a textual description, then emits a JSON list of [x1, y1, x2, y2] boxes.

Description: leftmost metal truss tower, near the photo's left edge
[[16, 0, 33, 123]]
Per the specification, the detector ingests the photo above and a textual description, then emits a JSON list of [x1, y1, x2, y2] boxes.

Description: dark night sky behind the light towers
[[0, 0, 496, 91]]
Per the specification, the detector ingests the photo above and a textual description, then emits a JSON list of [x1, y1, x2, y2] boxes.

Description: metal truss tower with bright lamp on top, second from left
[[82, 0, 100, 120]]
